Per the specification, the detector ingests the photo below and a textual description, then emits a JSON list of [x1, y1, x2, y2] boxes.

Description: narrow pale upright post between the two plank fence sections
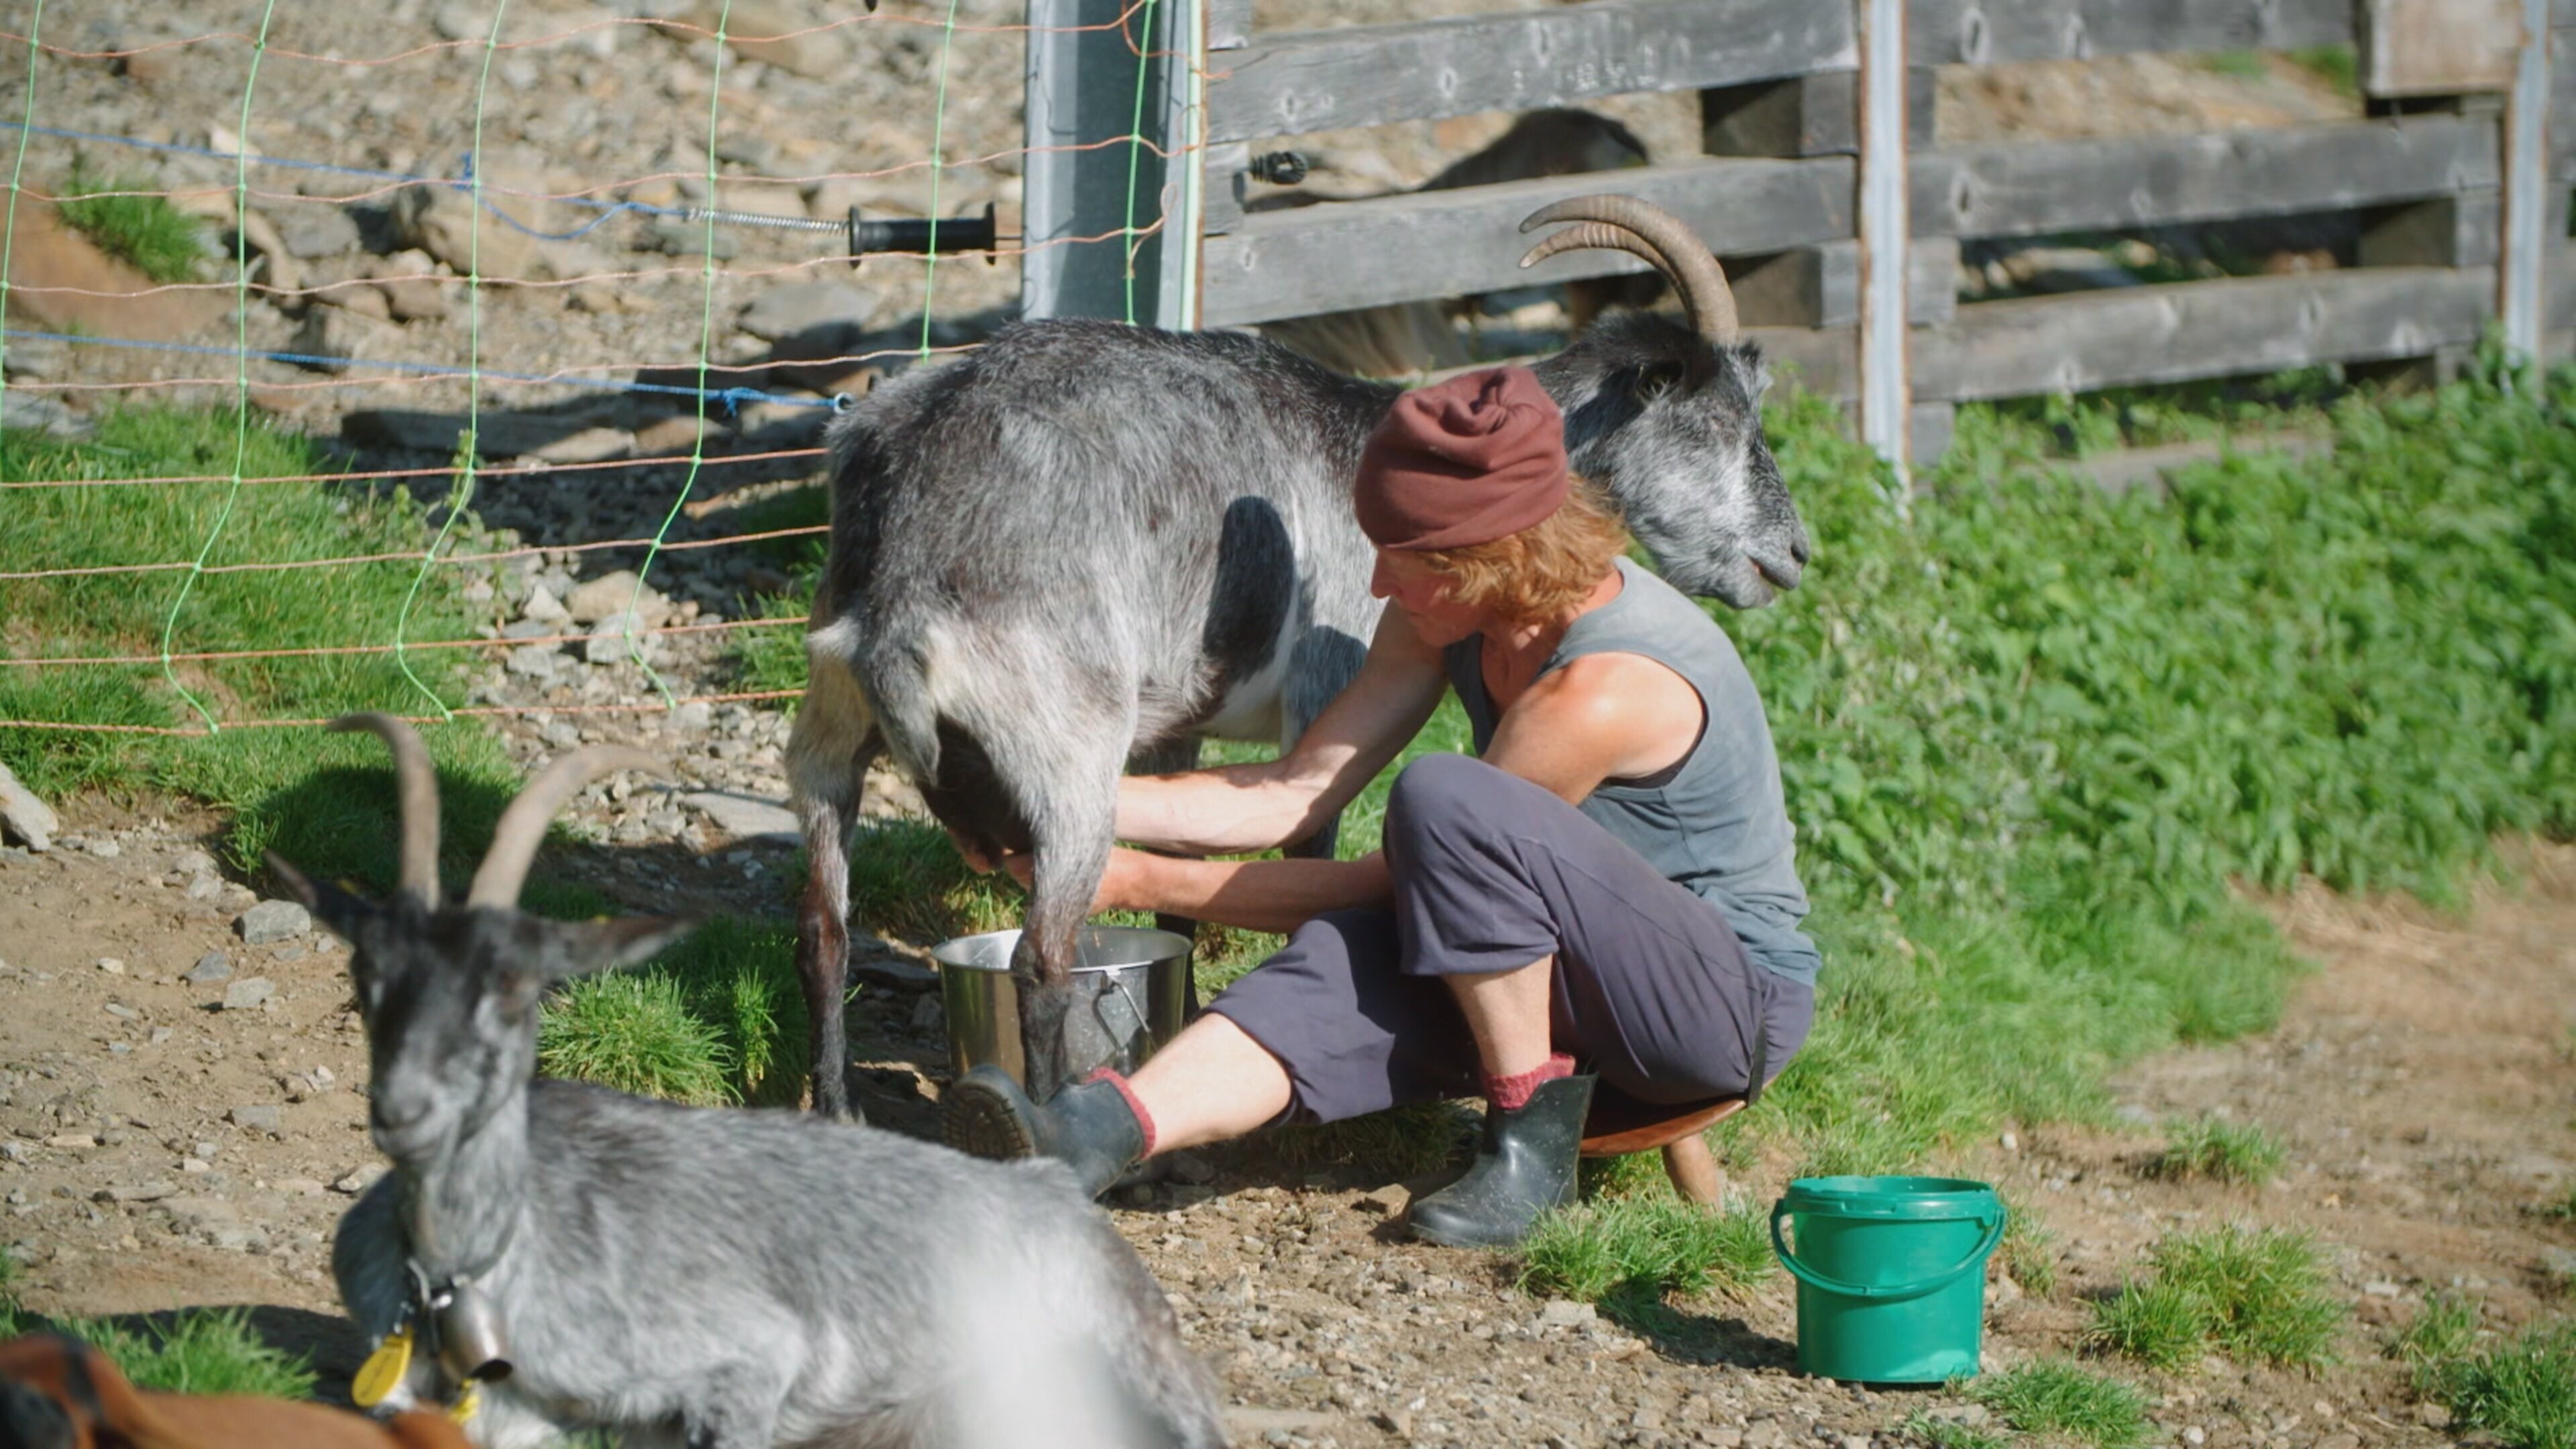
[[1860, 0, 1911, 490]]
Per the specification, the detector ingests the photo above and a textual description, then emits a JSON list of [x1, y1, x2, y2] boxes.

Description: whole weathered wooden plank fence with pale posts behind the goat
[[1159, 0, 2576, 453]]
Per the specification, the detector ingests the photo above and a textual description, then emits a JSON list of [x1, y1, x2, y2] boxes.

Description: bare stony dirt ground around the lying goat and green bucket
[[0, 799, 2576, 1449]]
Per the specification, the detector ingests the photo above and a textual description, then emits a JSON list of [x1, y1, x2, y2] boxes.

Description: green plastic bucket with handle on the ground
[[1772, 1178, 2004, 1385]]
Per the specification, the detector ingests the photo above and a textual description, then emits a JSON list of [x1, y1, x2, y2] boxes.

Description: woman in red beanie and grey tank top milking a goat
[[948, 369, 1816, 1245]]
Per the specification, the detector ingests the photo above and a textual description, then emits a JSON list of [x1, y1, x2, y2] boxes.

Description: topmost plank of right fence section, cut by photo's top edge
[[1907, 0, 2355, 64]]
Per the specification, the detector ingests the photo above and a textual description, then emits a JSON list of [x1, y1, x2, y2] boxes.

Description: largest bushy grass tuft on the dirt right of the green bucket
[[2086, 1225, 2344, 1372]]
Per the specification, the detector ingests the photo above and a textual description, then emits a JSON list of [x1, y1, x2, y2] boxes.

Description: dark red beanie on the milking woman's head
[[1352, 366, 1569, 549]]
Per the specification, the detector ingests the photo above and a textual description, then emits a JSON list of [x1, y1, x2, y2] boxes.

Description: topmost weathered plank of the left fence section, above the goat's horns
[[1208, 0, 1855, 142]]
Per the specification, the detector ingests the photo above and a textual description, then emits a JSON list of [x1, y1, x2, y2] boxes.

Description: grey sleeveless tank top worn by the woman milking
[[1442, 559, 1819, 985]]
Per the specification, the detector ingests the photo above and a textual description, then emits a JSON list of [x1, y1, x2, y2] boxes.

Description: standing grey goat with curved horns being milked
[[786, 196, 1809, 1114]]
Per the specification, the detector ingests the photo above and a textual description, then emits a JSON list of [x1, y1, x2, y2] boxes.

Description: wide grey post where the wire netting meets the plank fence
[[1020, 0, 1203, 325]]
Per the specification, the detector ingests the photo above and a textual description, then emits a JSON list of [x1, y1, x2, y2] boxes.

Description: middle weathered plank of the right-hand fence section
[[1911, 116, 2499, 237]]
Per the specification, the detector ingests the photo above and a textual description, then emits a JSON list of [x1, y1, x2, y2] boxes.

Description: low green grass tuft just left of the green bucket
[[1520, 1196, 1778, 1302]]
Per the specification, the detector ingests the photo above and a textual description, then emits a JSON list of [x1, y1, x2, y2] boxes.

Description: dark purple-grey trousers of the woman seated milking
[[1208, 755, 1816, 1122]]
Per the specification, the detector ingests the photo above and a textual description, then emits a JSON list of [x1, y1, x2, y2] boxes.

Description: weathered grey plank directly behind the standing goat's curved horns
[[1200, 157, 1852, 327]]
